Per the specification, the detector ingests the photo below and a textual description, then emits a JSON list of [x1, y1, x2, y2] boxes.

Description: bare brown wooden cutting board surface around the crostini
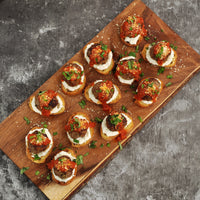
[[0, 0, 200, 200]]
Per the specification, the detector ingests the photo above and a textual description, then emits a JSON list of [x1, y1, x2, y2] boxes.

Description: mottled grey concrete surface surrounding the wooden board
[[0, 0, 200, 200]]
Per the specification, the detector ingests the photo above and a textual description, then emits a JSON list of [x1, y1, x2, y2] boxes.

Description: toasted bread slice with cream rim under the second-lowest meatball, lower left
[[25, 127, 53, 163]]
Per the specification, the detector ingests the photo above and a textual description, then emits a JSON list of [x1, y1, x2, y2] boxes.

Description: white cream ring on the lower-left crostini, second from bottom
[[25, 128, 53, 158]]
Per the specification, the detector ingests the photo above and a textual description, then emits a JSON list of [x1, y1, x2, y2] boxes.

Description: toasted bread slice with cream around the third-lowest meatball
[[66, 112, 94, 147]]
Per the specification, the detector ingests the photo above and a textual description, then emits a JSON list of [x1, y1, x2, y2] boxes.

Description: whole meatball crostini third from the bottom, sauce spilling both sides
[[65, 112, 95, 147]]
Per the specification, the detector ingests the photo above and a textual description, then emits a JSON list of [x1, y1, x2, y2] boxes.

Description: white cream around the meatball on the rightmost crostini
[[146, 44, 174, 67]]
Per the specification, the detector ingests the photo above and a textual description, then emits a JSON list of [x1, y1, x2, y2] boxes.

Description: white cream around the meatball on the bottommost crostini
[[52, 151, 76, 183]]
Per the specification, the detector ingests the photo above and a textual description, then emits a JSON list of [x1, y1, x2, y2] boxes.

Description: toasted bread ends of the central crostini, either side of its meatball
[[84, 80, 121, 105]]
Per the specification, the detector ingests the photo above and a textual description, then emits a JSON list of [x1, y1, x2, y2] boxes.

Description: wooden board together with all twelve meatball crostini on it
[[0, 0, 200, 199]]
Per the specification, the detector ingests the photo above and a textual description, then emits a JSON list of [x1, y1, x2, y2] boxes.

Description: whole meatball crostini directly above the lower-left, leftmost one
[[29, 90, 65, 117]]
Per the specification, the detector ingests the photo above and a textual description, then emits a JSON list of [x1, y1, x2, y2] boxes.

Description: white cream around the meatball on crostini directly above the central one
[[84, 43, 113, 70]]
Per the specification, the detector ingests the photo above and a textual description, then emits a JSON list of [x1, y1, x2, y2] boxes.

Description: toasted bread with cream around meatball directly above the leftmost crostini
[[28, 93, 65, 115]]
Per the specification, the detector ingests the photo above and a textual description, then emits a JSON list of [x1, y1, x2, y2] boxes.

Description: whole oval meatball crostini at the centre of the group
[[84, 80, 121, 104]]
